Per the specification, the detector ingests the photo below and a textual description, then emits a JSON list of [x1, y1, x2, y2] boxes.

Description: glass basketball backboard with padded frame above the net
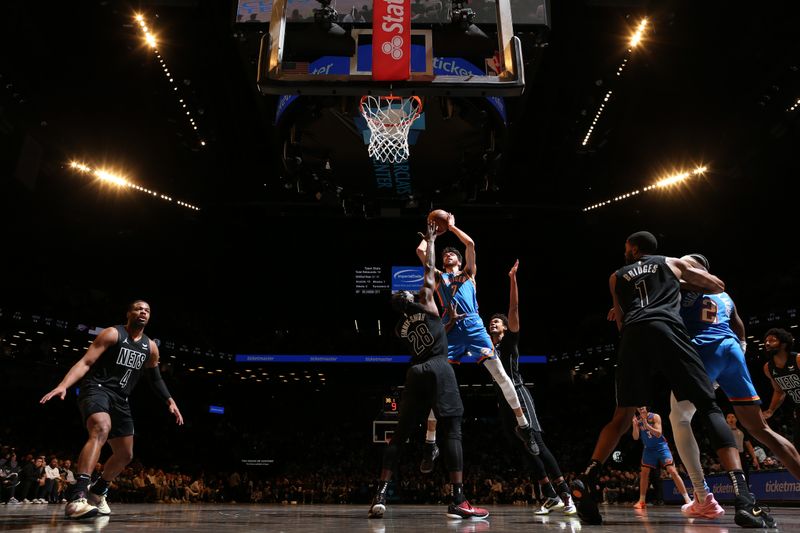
[[252, 0, 548, 96]]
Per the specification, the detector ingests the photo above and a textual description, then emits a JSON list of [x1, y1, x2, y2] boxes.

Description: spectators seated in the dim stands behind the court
[[0, 424, 781, 505]]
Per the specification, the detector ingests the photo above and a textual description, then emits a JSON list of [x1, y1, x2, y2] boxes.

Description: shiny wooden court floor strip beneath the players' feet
[[0, 502, 788, 533]]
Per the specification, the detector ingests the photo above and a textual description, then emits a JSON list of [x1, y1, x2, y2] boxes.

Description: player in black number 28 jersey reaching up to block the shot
[[368, 222, 489, 518]]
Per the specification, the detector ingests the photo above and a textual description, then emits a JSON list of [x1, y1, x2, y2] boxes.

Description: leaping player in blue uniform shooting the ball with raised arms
[[417, 214, 539, 466]]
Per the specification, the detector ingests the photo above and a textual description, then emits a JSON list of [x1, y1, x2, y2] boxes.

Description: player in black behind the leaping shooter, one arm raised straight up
[[488, 260, 577, 515]]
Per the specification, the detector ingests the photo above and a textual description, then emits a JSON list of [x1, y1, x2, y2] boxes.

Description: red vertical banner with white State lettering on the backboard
[[372, 0, 411, 81]]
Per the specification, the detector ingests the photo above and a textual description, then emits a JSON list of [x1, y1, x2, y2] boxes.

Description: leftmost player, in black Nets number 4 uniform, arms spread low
[[40, 300, 183, 518]]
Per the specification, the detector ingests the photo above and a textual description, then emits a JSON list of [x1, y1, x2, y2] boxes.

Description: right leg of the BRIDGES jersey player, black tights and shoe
[[654, 323, 775, 527]]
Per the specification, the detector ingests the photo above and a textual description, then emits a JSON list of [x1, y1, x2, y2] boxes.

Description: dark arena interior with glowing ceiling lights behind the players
[[0, 0, 800, 532]]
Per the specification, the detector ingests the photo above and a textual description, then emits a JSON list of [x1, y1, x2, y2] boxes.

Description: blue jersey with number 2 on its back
[[681, 292, 739, 346]]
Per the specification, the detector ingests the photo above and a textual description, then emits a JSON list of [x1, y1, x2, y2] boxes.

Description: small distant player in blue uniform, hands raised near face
[[632, 406, 692, 509]]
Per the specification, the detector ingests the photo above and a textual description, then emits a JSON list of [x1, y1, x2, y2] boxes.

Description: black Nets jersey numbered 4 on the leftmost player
[[81, 326, 150, 398]]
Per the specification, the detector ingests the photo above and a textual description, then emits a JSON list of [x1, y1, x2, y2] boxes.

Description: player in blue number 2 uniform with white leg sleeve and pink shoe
[[670, 254, 800, 518]]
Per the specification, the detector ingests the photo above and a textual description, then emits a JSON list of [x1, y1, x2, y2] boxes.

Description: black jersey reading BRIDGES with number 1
[[616, 255, 684, 329]]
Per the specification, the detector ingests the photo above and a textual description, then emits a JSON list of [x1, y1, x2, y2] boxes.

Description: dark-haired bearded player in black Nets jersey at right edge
[[764, 328, 800, 448]]
